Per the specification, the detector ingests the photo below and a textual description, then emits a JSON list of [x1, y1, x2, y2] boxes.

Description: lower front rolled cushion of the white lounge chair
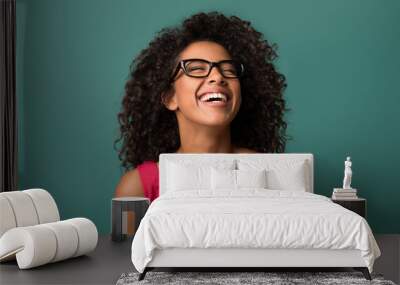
[[0, 218, 98, 269]]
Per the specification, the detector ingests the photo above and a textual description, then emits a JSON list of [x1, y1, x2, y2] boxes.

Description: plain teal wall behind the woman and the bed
[[17, 0, 400, 233]]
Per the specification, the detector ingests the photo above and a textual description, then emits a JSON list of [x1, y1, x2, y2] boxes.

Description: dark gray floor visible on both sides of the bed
[[0, 234, 400, 285]]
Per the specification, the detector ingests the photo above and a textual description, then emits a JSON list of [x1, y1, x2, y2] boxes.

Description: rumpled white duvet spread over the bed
[[132, 188, 380, 272]]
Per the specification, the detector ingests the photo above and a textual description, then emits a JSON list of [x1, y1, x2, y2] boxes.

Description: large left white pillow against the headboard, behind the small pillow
[[166, 161, 236, 191]]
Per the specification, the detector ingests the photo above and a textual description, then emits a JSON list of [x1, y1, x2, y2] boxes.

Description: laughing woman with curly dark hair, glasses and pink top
[[115, 12, 287, 201]]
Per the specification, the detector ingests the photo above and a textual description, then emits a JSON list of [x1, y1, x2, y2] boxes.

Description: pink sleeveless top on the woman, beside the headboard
[[137, 160, 159, 202]]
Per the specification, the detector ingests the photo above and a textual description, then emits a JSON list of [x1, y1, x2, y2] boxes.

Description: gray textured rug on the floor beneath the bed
[[117, 271, 395, 285]]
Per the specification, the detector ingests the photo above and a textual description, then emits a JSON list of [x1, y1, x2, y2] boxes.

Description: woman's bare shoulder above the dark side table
[[114, 168, 144, 197]]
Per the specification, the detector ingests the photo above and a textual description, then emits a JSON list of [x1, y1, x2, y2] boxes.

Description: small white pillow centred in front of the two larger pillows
[[211, 168, 267, 190]]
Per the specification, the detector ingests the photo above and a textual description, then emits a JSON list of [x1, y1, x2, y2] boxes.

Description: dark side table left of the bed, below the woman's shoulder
[[111, 197, 150, 241]]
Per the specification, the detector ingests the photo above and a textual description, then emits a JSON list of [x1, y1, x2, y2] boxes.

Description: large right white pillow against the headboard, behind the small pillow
[[238, 159, 310, 191]]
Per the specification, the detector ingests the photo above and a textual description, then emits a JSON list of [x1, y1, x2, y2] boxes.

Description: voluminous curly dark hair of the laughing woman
[[115, 12, 288, 170]]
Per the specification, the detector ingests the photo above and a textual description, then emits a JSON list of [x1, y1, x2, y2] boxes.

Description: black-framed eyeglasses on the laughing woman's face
[[171, 58, 244, 80]]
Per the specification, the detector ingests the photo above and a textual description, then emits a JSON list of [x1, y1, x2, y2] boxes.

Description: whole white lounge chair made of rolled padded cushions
[[0, 189, 98, 269]]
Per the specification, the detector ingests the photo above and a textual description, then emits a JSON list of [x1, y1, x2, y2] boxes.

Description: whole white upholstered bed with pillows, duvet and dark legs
[[131, 153, 380, 280]]
